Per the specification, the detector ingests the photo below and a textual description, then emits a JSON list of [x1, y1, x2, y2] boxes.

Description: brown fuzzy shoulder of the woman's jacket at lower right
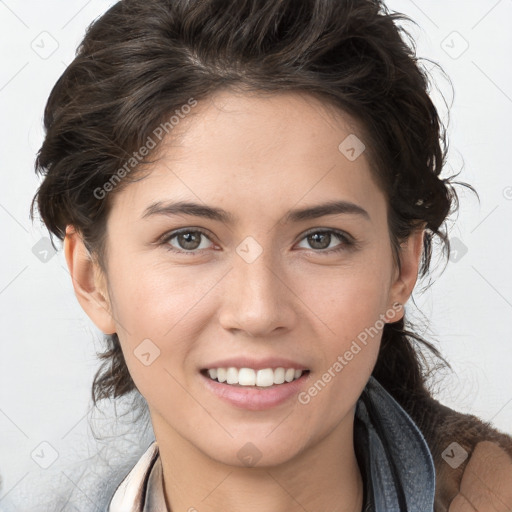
[[411, 399, 512, 512]]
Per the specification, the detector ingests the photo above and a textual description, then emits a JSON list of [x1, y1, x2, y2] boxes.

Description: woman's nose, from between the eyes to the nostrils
[[219, 245, 297, 337]]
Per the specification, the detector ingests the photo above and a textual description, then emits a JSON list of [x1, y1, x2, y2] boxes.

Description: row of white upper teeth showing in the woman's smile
[[204, 366, 302, 387]]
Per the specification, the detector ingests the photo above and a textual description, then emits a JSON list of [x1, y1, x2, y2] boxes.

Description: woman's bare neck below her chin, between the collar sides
[[152, 414, 363, 512]]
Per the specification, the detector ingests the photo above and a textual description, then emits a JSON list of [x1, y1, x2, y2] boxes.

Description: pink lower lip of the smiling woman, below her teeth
[[200, 372, 310, 411]]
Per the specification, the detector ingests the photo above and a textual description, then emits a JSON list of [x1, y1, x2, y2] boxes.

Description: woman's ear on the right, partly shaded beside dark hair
[[390, 227, 425, 322]]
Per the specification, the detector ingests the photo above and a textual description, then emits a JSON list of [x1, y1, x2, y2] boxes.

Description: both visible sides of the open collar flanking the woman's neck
[[108, 377, 435, 512]]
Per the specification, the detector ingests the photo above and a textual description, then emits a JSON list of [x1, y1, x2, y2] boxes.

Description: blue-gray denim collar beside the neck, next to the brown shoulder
[[354, 377, 435, 512]]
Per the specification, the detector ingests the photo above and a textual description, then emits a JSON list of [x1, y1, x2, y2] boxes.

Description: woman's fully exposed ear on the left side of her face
[[64, 225, 116, 334]]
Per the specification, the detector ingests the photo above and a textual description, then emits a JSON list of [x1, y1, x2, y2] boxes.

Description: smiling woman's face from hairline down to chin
[[69, 91, 421, 465]]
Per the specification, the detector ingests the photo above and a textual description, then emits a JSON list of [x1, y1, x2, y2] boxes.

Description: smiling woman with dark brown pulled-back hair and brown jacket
[[34, 0, 512, 512]]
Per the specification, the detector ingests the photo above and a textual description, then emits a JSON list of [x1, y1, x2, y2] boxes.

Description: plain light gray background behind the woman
[[0, 0, 512, 511]]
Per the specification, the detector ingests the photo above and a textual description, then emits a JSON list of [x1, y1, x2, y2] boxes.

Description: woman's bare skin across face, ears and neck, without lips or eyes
[[65, 90, 423, 512]]
